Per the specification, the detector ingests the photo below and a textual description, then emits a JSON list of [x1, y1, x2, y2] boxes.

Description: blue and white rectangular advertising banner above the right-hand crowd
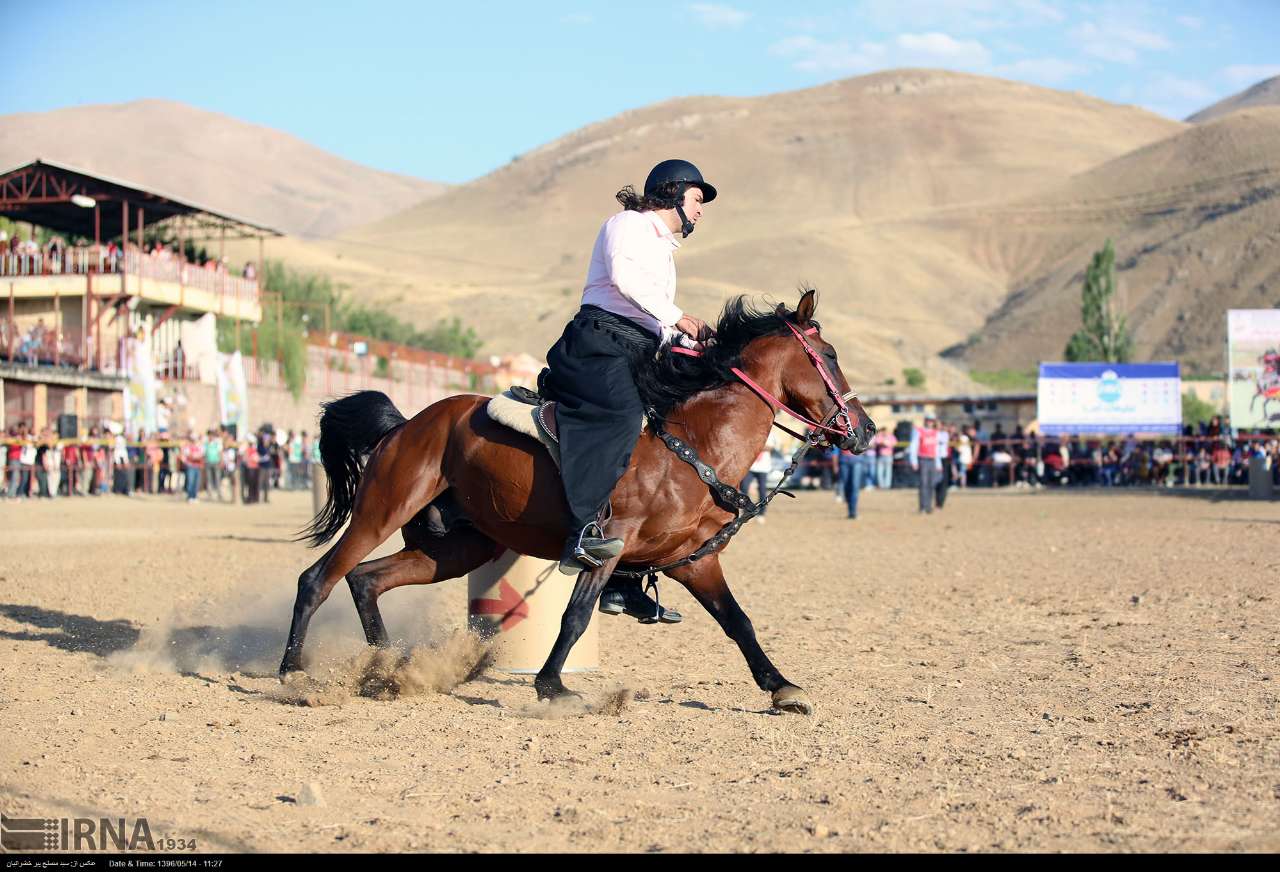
[[1037, 362, 1183, 435]]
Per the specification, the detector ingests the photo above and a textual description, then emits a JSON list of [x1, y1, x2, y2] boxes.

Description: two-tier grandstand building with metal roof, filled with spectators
[[0, 160, 280, 437]]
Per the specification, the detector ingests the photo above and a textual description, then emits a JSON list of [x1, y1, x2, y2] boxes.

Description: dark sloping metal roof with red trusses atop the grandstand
[[0, 159, 284, 241]]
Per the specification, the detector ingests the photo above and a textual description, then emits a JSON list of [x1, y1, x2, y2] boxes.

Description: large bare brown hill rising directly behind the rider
[[274, 70, 1181, 388]]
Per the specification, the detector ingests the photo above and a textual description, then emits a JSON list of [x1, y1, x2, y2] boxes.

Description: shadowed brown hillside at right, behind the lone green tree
[[938, 108, 1280, 371]]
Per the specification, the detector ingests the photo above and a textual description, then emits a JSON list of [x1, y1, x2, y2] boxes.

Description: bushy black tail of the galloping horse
[[298, 391, 406, 548]]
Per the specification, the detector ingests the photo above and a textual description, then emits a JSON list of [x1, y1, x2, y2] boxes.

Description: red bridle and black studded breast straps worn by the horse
[[613, 321, 856, 578]]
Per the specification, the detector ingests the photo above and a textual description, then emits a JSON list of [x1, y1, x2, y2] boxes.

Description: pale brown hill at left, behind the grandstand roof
[[0, 100, 444, 237]]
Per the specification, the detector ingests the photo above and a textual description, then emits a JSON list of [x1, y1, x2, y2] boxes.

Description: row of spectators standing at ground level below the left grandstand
[[0, 424, 320, 503]]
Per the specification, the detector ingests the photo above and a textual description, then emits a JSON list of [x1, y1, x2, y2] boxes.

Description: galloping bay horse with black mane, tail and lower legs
[[280, 289, 876, 713]]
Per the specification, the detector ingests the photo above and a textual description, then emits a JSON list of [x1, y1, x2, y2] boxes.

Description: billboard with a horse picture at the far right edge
[[1226, 309, 1280, 430]]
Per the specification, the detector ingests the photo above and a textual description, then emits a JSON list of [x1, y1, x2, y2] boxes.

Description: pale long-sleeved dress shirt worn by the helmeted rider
[[582, 211, 685, 343]]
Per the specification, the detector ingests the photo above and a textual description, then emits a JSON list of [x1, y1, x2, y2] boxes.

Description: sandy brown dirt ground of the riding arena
[[0, 492, 1280, 852]]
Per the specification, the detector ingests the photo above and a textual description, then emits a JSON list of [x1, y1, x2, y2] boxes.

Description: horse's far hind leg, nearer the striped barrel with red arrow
[[347, 528, 502, 648]]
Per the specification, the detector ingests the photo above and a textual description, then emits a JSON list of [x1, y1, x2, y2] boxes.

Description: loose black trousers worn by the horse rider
[[540, 306, 658, 534]]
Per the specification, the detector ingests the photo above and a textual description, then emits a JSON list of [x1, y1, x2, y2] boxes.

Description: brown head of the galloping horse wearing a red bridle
[[773, 288, 876, 453]]
